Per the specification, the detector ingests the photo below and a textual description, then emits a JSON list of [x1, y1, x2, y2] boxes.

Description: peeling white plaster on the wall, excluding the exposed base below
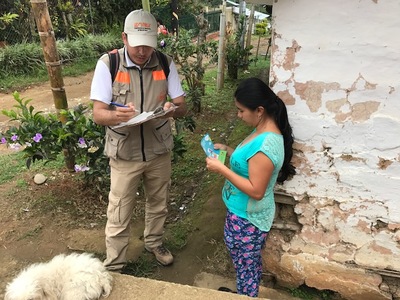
[[270, 0, 400, 271]]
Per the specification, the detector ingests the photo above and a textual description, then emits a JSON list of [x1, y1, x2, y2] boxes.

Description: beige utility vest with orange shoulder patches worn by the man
[[101, 48, 173, 161]]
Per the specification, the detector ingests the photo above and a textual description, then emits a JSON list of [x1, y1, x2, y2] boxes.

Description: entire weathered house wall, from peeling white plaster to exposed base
[[247, 0, 400, 300]]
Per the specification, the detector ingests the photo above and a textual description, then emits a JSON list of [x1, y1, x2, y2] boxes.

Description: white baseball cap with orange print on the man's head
[[124, 9, 157, 48]]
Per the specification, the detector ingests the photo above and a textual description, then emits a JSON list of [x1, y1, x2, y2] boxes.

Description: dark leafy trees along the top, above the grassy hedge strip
[[0, 0, 220, 45]]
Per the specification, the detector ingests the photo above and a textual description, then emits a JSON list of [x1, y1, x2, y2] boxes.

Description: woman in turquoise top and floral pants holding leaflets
[[206, 78, 295, 297]]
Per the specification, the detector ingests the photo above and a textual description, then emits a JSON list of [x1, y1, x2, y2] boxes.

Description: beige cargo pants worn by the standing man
[[104, 153, 171, 270]]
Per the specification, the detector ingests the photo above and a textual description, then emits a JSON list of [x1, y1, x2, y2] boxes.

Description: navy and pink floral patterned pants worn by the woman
[[224, 211, 268, 297]]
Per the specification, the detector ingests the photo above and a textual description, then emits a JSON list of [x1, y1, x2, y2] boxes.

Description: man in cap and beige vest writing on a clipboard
[[90, 10, 187, 272]]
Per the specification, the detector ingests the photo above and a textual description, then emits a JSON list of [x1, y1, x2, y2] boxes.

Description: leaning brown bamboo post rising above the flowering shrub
[[31, 0, 68, 122]]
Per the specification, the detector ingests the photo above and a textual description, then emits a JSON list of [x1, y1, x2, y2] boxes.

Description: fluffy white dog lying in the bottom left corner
[[4, 253, 112, 300]]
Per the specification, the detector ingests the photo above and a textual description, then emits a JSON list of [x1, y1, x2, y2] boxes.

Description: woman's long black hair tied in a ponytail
[[234, 77, 295, 183]]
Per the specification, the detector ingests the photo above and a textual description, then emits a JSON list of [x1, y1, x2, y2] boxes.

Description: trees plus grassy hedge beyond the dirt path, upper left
[[0, 0, 228, 92]]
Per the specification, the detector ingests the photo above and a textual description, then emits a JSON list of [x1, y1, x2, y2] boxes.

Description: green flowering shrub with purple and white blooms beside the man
[[0, 92, 109, 190]]
